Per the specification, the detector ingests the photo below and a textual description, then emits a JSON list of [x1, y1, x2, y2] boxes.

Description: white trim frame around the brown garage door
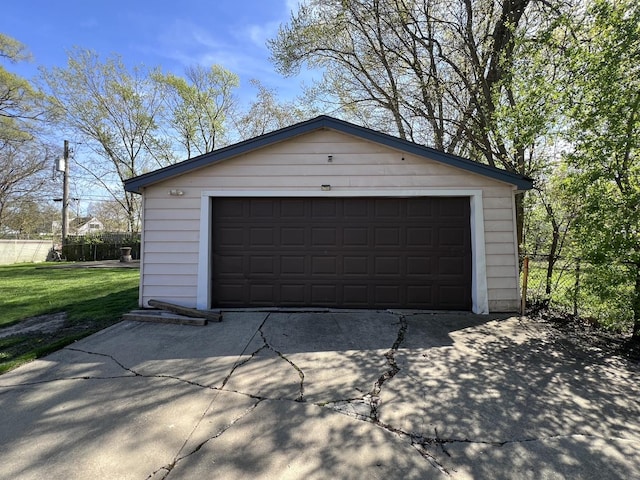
[[196, 188, 489, 314]]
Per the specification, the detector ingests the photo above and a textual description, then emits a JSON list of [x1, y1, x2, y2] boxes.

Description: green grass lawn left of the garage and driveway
[[0, 264, 140, 373]]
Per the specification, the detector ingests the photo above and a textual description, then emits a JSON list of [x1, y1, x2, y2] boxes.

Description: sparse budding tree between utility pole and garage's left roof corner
[[41, 49, 173, 231]]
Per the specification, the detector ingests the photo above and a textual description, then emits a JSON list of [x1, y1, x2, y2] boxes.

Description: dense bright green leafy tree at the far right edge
[[566, 0, 640, 340]]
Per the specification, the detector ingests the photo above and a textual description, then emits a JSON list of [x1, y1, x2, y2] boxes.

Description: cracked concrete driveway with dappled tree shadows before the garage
[[0, 311, 640, 480]]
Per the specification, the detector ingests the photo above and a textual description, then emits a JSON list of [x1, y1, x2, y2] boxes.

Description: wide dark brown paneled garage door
[[212, 197, 471, 310]]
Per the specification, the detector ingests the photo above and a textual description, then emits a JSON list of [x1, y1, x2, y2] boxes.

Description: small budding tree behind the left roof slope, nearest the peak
[[153, 65, 239, 158]]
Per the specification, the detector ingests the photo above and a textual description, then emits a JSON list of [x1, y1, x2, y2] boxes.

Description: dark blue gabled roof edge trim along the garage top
[[124, 115, 533, 193]]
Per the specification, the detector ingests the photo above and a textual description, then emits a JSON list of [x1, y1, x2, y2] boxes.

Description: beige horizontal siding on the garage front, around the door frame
[[141, 130, 519, 311]]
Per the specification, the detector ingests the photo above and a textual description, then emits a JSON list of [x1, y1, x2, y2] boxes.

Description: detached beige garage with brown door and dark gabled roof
[[125, 116, 532, 313]]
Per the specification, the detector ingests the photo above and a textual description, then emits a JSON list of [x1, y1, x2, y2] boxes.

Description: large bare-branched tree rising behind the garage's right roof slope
[[269, 0, 576, 246]]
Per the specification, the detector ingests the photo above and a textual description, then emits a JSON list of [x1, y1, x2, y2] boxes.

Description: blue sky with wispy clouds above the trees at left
[[0, 0, 310, 101]]
